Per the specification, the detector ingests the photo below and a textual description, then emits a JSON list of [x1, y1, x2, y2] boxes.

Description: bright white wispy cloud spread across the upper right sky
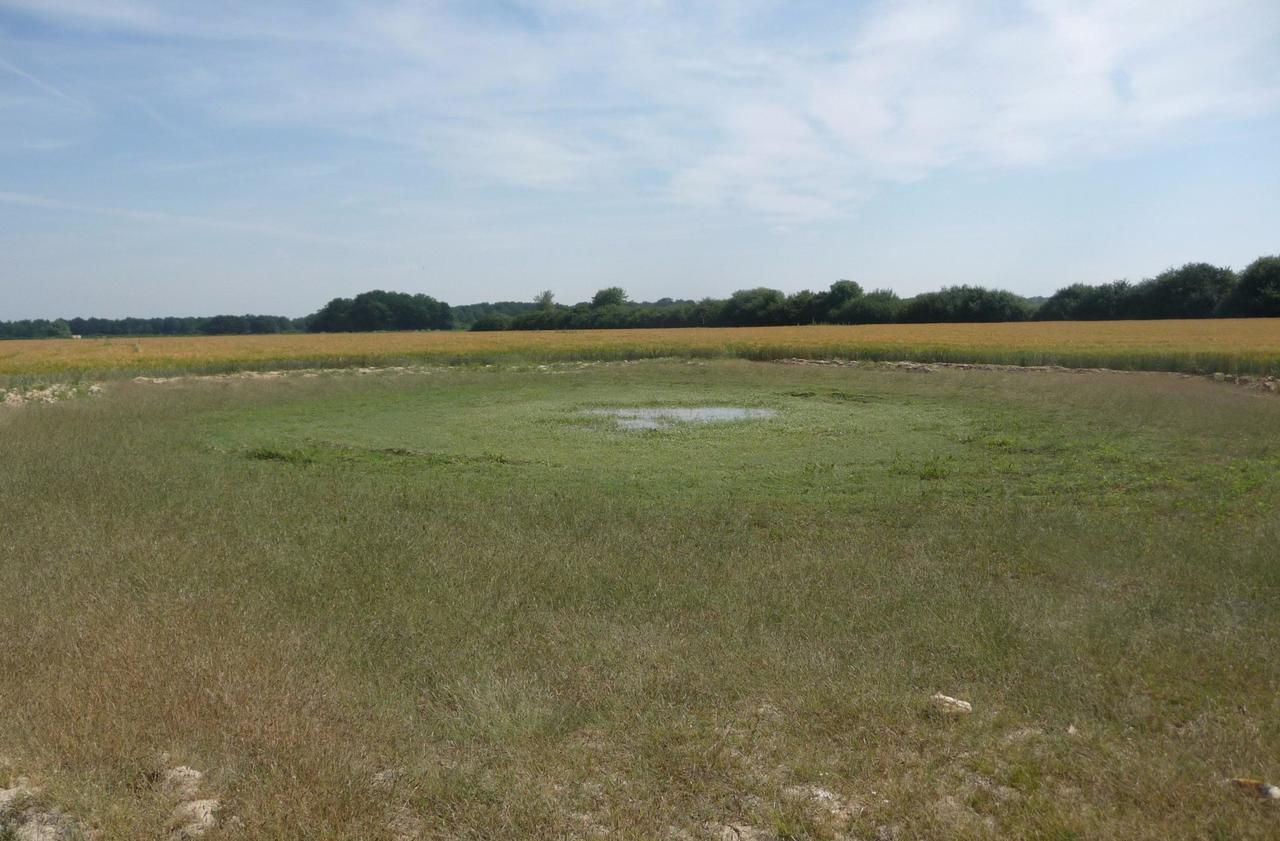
[[678, 3, 1280, 213]]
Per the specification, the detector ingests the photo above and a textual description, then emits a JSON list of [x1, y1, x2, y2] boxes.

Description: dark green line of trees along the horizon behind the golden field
[[0, 256, 1280, 338]]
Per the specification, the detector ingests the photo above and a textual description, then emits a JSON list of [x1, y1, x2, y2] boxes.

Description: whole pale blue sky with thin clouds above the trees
[[0, 0, 1280, 319]]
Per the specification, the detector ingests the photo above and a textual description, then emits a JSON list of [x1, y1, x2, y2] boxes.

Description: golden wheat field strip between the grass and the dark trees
[[0, 319, 1280, 378]]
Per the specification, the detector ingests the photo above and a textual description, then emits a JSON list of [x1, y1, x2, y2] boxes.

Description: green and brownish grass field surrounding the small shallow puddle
[[0, 360, 1280, 841]]
